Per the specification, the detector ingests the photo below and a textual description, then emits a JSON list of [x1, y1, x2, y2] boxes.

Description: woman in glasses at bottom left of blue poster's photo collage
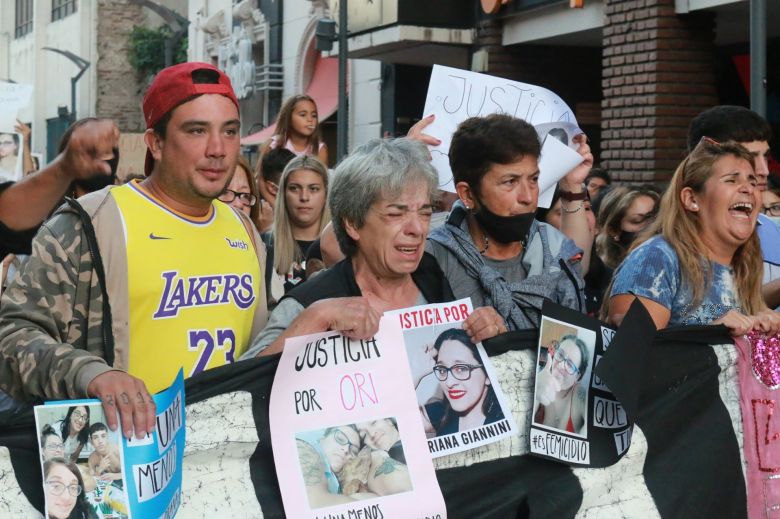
[[43, 458, 96, 519]]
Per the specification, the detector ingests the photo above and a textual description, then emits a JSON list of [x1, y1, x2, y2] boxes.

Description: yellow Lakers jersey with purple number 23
[[111, 182, 264, 393]]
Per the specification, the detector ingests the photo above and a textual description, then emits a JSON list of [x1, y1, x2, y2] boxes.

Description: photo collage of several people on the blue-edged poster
[[35, 403, 128, 519]]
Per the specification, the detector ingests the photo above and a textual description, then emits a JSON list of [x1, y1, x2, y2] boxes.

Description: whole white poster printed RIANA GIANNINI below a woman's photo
[[393, 300, 515, 457]]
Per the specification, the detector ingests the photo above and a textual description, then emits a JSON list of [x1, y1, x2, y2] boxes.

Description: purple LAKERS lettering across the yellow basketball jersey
[[152, 270, 255, 319]]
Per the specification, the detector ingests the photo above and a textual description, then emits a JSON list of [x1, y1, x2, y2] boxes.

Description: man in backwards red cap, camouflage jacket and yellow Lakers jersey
[[0, 63, 267, 438]]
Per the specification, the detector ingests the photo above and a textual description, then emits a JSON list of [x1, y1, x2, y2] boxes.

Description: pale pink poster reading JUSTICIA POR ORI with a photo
[[270, 317, 446, 519]]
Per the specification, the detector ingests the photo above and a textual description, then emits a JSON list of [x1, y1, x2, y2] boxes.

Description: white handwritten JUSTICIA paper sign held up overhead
[[423, 65, 583, 192]]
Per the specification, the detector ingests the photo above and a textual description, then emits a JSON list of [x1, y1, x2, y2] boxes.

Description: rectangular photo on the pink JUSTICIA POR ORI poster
[[295, 417, 413, 509]]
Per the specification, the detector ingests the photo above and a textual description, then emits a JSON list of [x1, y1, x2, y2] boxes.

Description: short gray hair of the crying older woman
[[328, 138, 439, 257]]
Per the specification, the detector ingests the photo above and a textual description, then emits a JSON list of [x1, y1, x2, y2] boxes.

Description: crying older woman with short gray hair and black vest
[[244, 138, 506, 358]]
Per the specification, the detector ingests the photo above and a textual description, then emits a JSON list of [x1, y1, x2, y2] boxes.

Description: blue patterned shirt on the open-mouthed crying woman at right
[[610, 236, 741, 326]]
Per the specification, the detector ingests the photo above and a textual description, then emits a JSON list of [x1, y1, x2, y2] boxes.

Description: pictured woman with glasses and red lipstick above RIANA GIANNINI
[[416, 328, 504, 437]]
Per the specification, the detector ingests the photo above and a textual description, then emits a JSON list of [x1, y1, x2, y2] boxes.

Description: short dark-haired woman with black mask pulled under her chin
[[426, 114, 593, 330]]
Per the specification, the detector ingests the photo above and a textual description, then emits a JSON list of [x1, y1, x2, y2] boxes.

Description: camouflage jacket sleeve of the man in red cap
[[0, 212, 111, 400]]
